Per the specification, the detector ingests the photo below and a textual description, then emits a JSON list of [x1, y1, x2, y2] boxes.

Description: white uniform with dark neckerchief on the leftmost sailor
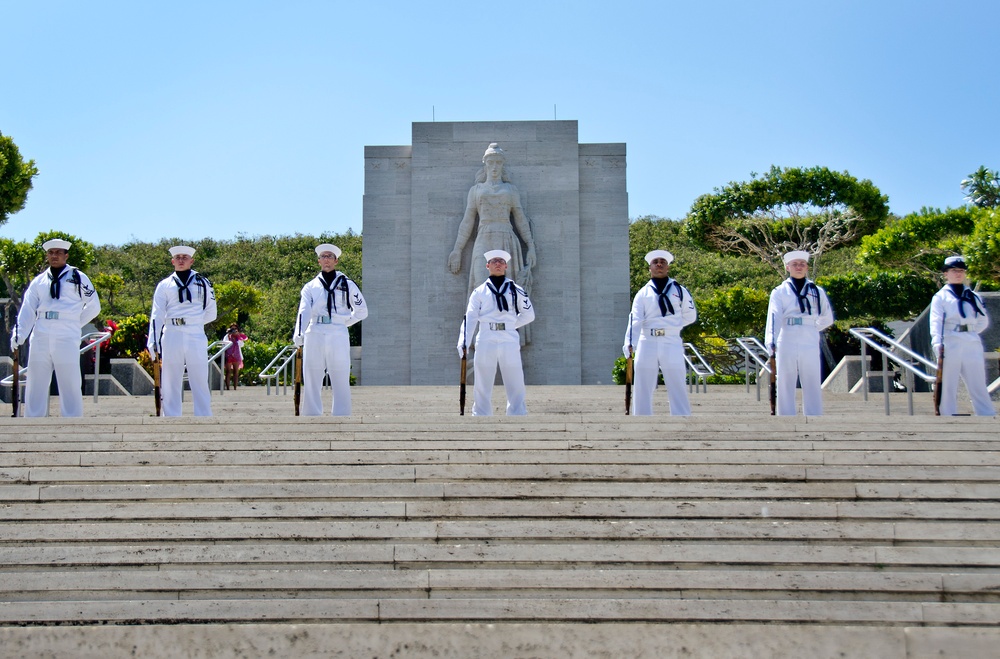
[[11, 264, 101, 417]]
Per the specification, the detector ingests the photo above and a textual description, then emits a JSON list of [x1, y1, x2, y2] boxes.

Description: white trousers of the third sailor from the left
[[302, 325, 351, 416]]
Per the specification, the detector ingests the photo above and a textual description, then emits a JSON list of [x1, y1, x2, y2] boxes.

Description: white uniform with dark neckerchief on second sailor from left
[[147, 270, 216, 416]]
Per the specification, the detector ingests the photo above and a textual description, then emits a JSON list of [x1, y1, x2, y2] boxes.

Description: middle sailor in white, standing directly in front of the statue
[[458, 249, 535, 416]]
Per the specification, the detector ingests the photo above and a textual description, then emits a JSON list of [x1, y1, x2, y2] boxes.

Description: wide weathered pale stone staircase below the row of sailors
[[0, 387, 1000, 657]]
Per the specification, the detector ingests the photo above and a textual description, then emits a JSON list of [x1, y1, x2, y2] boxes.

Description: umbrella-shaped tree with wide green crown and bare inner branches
[[684, 166, 889, 275]]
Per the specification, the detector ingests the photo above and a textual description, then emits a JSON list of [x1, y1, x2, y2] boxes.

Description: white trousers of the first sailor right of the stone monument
[[632, 336, 691, 416]]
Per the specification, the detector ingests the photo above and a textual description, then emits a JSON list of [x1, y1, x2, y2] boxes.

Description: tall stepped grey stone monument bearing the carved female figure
[[360, 121, 631, 384]]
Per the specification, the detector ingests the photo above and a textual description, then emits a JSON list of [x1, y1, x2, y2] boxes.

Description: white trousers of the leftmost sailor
[[24, 326, 83, 417]]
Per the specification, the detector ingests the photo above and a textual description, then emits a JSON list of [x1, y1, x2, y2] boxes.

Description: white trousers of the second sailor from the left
[[160, 326, 212, 416]]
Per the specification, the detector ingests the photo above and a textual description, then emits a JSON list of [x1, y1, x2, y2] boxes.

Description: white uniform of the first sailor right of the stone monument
[[622, 277, 698, 416]]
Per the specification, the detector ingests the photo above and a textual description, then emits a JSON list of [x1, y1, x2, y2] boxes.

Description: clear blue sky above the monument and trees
[[0, 0, 1000, 245]]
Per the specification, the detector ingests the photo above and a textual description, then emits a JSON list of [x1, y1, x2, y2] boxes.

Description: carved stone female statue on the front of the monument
[[448, 142, 535, 343]]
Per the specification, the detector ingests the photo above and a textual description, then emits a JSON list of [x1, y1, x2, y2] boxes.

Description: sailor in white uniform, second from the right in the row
[[764, 250, 833, 416]]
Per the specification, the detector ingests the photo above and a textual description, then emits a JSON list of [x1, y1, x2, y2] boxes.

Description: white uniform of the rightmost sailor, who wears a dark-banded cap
[[930, 284, 996, 416]]
